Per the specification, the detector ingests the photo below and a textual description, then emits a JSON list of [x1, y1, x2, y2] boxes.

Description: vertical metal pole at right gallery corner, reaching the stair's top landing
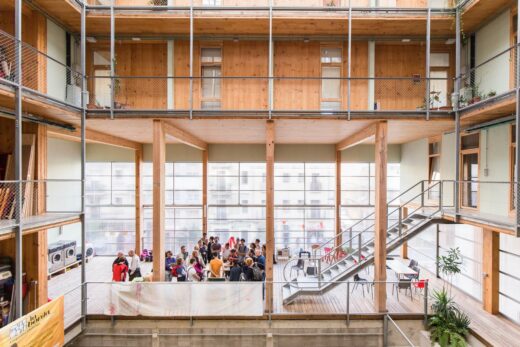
[[453, 7, 461, 222]]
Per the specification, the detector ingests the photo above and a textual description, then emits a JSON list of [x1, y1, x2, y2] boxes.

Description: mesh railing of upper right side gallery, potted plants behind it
[[459, 45, 518, 109]]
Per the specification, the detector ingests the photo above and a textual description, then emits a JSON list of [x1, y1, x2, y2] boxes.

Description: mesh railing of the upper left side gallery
[[0, 30, 81, 107]]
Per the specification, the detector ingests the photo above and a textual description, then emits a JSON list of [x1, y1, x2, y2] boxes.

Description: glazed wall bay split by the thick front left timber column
[[142, 162, 203, 254]]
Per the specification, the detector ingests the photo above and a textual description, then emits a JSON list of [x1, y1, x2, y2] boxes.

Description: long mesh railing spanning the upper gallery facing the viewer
[[88, 76, 452, 115]]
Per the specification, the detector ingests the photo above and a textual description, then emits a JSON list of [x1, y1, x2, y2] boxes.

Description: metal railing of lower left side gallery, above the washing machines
[[0, 179, 81, 230]]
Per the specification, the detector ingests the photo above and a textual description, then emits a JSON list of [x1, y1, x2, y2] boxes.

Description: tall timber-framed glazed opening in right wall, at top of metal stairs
[[460, 133, 480, 208]]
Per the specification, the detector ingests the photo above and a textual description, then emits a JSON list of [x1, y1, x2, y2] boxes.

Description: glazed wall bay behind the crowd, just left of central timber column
[[208, 162, 266, 244]]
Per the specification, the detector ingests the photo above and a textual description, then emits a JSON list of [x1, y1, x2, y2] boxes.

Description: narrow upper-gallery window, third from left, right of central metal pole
[[321, 48, 341, 111]]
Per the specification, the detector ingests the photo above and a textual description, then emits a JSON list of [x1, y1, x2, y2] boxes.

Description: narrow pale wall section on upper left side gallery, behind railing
[[47, 20, 67, 100]]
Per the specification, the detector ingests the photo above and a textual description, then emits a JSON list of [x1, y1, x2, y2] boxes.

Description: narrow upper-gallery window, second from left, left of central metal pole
[[200, 48, 222, 110]]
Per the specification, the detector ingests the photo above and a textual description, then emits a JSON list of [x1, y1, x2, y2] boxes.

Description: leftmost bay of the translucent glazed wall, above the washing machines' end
[[85, 162, 135, 255]]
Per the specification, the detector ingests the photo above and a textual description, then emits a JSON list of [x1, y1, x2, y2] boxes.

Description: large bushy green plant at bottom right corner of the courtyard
[[428, 288, 471, 347]]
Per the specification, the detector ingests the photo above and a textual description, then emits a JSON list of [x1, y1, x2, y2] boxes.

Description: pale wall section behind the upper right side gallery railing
[[475, 10, 510, 94]]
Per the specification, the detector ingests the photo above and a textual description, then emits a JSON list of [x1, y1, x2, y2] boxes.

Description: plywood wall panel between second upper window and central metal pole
[[222, 41, 269, 110]]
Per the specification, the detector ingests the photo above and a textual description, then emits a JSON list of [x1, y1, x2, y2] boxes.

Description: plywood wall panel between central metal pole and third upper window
[[274, 42, 321, 110]]
